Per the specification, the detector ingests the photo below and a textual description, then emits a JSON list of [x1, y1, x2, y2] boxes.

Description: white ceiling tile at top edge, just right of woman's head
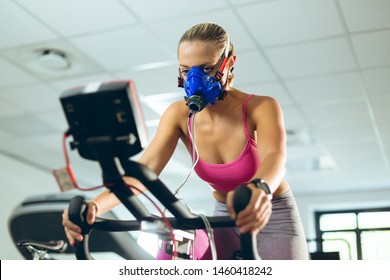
[[237, 0, 343, 47]]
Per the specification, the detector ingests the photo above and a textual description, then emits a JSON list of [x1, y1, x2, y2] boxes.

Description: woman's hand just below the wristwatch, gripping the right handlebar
[[226, 184, 272, 235]]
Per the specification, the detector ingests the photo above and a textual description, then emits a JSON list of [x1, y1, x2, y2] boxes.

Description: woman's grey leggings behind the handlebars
[[213, 191, 309, 260]]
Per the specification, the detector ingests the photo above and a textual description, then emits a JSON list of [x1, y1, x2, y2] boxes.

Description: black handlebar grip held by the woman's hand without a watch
[[68, 195, 92, 260]]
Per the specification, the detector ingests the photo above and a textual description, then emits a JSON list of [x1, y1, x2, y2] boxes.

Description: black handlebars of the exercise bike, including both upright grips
[[68, 161, 260, 260]]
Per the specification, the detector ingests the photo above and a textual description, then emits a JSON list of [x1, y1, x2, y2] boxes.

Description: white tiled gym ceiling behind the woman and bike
[[0, 0, 390, 206]]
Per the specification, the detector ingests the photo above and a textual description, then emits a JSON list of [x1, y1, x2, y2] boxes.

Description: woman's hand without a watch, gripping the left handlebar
[[62, 201, 98, 246]]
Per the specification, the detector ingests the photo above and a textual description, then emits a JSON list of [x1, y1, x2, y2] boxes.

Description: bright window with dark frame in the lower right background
[[315, 208, 390, 260]]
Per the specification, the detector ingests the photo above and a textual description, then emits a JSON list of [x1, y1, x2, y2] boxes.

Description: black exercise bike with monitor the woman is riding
[[10, 81, 260, 260]]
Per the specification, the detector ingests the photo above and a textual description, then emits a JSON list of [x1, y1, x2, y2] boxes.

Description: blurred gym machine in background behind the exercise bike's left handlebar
[[8, 193, 152, 260]]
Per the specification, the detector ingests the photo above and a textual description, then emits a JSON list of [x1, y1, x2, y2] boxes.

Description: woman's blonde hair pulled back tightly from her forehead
[[178, 22, 234, 56]]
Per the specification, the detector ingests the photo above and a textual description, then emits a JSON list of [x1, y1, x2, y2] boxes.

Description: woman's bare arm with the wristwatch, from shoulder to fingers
[[227, 97, 286, 234]]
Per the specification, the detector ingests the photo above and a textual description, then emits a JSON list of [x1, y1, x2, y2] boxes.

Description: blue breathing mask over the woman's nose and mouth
[[184, 66, 224, 113]]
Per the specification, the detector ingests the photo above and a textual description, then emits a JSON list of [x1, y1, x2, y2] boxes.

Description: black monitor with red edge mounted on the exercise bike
[[60, 80, 148, 161]]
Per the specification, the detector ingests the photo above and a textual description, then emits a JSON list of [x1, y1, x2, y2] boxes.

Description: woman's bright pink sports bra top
[[189, 95, 260, 192]]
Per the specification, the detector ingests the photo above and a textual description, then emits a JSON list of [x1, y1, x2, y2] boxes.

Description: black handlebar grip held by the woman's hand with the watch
[[233, 185, 261, 260]]
